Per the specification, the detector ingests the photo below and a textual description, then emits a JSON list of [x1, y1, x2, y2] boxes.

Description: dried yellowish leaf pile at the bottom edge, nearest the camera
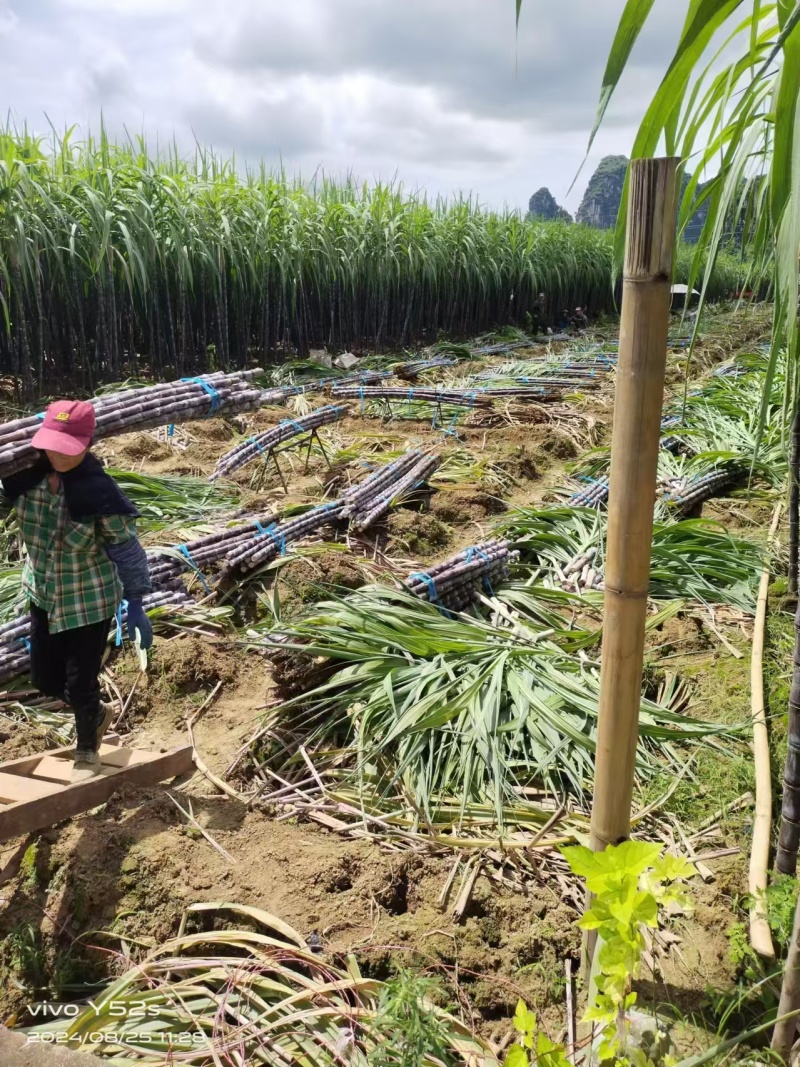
[[20, 903, 488, 1067]]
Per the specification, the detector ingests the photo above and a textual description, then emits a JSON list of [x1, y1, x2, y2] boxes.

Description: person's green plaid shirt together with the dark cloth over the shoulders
[[3, 456, 138, 634]]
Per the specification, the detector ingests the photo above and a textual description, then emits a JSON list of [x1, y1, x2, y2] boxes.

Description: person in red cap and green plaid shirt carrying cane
[[2, 400, 153, 782]]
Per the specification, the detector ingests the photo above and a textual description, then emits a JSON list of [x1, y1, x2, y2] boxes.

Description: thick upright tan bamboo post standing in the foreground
[[592, 159, 678, 851]]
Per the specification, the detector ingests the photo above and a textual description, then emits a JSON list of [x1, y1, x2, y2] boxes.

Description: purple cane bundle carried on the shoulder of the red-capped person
[[0, 368, 265, 478]]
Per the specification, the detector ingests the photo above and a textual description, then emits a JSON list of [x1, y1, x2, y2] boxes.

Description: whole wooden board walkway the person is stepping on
[[0, 737, 193, 841]]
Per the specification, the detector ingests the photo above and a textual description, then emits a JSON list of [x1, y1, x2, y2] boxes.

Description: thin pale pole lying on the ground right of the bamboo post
[[750, 505, 783, 959]]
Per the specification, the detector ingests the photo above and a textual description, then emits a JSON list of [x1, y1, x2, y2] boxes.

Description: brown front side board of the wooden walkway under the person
[[0, 745, 194, 841]]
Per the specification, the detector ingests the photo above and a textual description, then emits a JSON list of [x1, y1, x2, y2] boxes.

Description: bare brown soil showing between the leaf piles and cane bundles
[[0, 311, 776, 1063]]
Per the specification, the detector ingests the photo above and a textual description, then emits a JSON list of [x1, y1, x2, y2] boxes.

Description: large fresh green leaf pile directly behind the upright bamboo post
[[257, 587, 724, 826]]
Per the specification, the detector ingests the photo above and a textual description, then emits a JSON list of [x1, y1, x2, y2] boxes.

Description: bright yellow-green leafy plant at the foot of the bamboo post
[[506, 841, 694, 1067]]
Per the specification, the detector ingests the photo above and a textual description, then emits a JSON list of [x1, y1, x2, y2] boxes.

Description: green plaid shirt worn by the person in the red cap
[[14, 477, 137, 634]]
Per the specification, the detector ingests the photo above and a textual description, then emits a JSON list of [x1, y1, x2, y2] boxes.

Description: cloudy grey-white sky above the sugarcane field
[[0, 0, 686, 209]]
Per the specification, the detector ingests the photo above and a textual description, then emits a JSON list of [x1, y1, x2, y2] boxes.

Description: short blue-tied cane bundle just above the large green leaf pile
[[405, 539, 519, 611]]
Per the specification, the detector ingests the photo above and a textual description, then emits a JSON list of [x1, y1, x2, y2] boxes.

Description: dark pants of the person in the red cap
[[31, 604, 111, 752]]
